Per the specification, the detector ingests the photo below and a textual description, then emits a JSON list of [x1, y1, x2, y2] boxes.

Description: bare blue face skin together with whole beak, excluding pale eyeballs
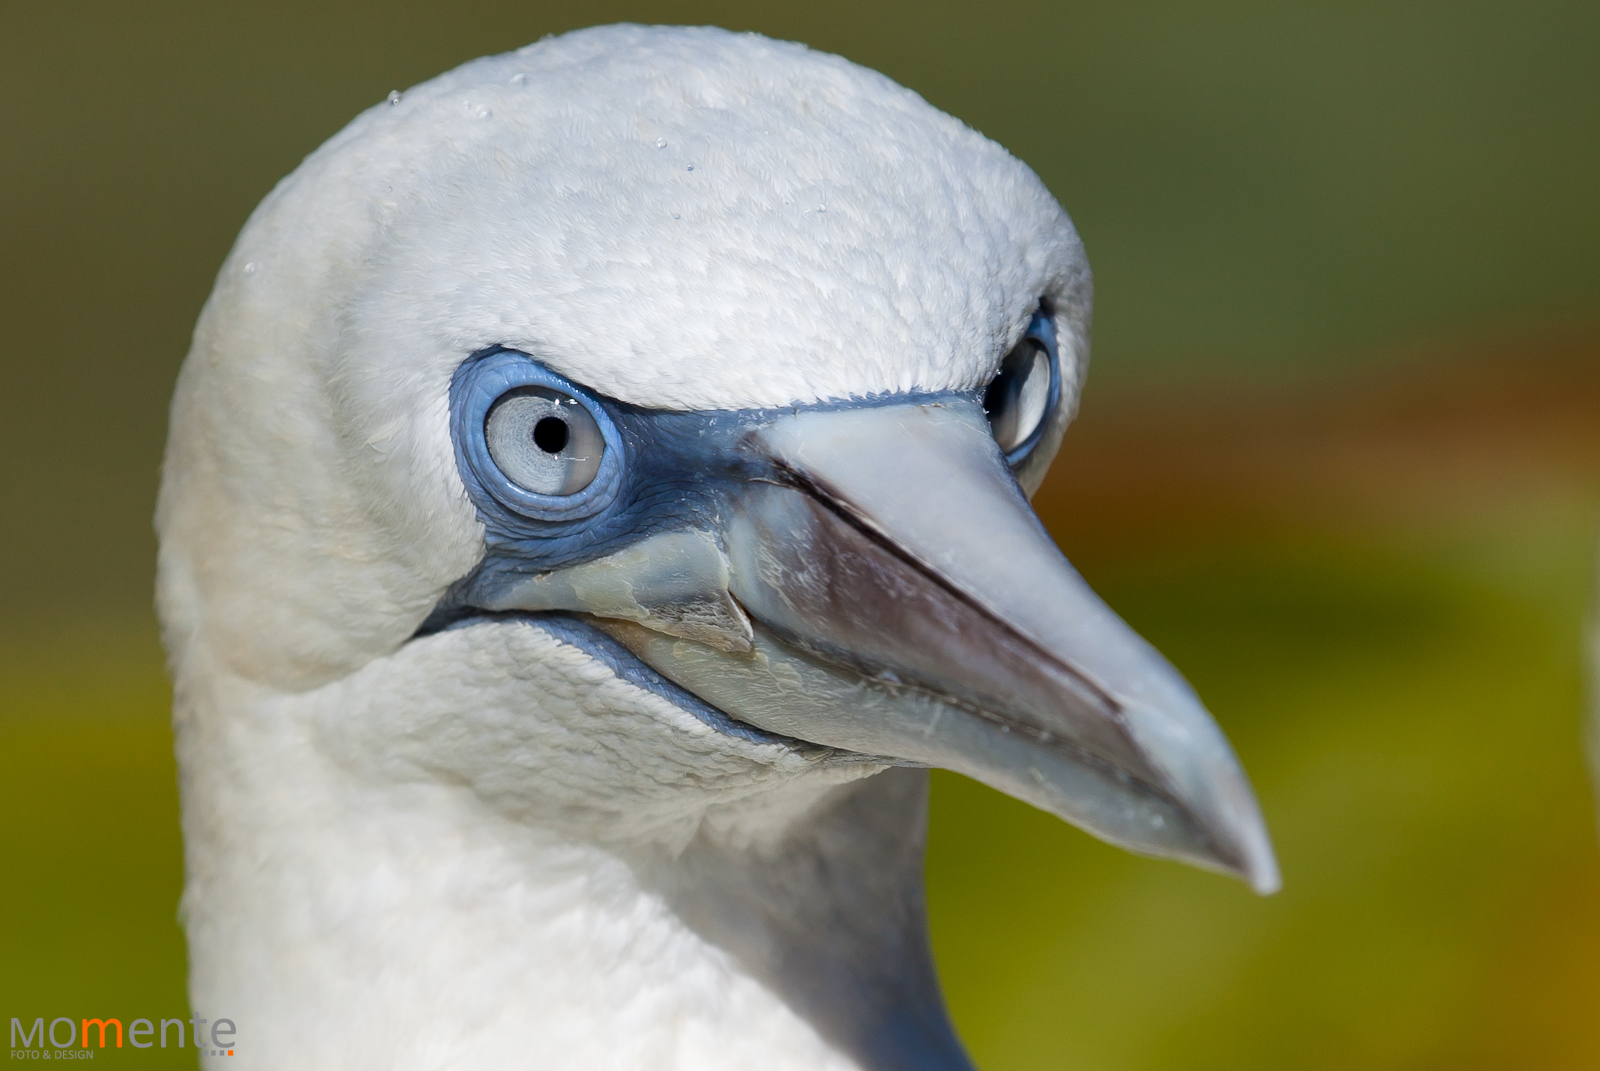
[[435, 317, 1278, 892]]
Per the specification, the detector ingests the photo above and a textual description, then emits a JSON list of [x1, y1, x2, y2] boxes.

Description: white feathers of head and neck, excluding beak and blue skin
[[158, 26, 1274, 1069]]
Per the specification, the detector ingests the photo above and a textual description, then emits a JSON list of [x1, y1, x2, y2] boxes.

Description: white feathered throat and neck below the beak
[[178, 624, 962, 1071]]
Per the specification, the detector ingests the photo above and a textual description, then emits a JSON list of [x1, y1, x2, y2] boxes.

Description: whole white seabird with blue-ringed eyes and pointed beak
[[157, 26, 1277, 1071]]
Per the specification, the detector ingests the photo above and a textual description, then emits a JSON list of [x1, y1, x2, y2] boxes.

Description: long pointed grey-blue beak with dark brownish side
[[486, 400, 1278, 893]]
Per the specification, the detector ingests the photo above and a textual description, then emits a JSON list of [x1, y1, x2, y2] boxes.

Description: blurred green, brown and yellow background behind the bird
[[0, 0, 1600, 1071]]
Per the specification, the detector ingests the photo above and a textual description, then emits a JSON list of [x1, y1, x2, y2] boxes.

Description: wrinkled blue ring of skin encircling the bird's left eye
[[450, 347, 624, 523]]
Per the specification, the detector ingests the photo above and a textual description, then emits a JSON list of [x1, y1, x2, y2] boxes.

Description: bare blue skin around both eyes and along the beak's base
[[438, 314, 1061, 632]]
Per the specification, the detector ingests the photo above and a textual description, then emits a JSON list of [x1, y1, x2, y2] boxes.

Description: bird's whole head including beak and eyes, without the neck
[[158, 26, 1277, 1066]]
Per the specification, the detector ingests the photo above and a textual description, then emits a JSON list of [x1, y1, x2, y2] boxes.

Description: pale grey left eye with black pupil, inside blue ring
[[483, 386, 605, 495]]
